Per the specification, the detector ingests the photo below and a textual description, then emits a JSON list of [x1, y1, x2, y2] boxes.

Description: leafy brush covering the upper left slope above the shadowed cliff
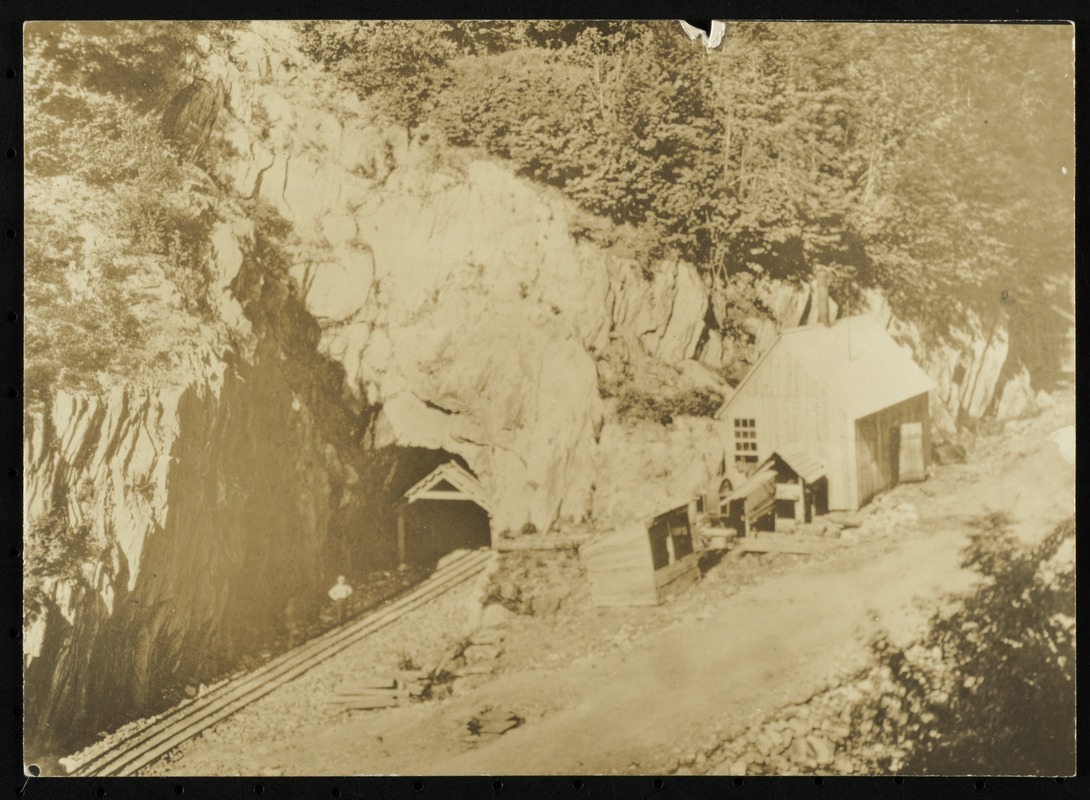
[[24, 23, 227, 404]]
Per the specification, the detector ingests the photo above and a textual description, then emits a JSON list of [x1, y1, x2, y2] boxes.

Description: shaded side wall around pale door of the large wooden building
[[856, 393, 931, 506]]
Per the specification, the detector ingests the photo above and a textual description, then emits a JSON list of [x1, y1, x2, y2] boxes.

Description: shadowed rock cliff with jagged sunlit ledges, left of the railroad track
[[24, 210, 374, 752]]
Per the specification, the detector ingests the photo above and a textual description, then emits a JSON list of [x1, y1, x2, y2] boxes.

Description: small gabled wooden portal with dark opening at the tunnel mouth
[[398, 461, 492, 565]]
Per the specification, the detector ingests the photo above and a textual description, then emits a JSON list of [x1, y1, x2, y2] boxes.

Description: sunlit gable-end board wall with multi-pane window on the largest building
[[722, 342, 857, 510]]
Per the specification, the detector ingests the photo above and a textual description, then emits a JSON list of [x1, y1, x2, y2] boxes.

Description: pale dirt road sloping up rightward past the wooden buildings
[[147, 401, 1074, 775]]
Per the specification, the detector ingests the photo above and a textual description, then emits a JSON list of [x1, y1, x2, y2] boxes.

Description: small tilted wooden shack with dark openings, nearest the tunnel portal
[[579, 504, 700, 606]]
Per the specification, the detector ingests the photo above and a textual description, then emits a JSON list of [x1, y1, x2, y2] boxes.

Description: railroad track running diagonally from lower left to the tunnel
[[70, 550, 491, 777]]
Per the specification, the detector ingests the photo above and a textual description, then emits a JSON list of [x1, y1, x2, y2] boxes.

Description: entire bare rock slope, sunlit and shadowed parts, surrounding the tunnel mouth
[[24, 23, 1055, 762]]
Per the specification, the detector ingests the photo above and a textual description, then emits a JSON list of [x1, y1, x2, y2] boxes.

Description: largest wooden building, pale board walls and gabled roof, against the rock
[[716, 316, 932, 510]]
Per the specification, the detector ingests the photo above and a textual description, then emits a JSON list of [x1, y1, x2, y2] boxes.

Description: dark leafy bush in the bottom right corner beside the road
[[857, 516, 1075, 775]]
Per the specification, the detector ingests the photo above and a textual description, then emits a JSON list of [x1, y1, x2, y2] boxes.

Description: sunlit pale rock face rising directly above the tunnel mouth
[[190, 24, 710, 530]]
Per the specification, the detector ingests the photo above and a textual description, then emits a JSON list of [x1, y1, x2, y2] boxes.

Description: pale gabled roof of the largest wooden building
[[716, 315, 934, 420]]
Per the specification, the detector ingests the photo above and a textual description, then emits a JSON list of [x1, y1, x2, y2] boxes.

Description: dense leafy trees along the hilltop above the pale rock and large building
[[294, 21, 1074, 336]]
